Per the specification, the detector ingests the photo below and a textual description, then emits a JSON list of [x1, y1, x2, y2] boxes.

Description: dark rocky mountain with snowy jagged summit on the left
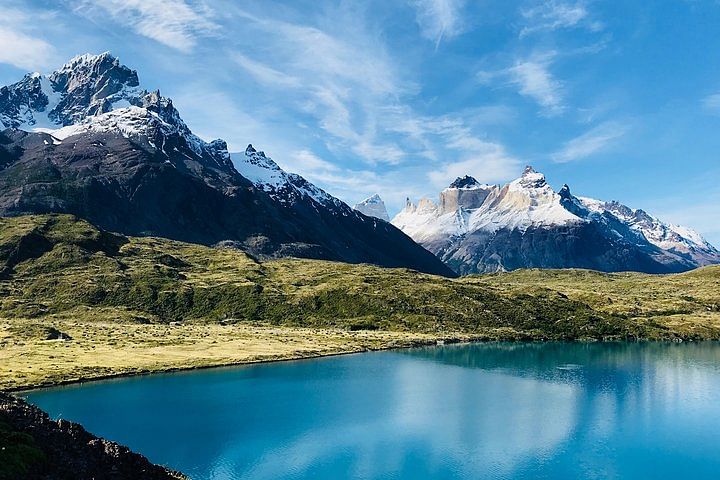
[[0, 53, 452, 275]]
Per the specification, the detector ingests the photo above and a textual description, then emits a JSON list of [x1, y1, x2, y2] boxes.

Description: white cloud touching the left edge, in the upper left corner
[[0, 8, 57, 70]]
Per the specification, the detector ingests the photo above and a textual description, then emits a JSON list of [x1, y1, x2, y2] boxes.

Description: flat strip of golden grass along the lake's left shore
[[0, 312, 484, 390]]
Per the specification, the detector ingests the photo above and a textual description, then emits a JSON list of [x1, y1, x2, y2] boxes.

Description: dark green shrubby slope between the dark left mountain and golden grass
[[0, 216, 643, 339]]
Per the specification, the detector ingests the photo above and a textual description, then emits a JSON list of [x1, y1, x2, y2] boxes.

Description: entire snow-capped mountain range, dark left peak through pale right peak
[[0, 53, 720, 276]]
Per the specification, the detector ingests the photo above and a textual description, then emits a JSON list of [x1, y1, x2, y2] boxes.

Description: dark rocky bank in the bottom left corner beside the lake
[[0, 392, 186, 480]]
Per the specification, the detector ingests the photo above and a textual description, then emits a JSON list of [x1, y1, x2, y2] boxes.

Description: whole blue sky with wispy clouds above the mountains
[[0, 0, 720, 245]]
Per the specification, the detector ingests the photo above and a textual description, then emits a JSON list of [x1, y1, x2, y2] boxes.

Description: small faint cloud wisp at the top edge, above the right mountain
[[520, 0, 602, 37]]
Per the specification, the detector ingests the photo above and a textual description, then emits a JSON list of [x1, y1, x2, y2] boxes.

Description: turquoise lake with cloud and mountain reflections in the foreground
[[21, 343, 720, 479]]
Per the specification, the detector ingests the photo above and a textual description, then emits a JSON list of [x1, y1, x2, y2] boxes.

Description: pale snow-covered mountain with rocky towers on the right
[[392, 167, 720, 274]]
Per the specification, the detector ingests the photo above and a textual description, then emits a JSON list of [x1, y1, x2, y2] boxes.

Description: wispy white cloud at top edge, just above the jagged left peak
[[70, 0, 218, 52]]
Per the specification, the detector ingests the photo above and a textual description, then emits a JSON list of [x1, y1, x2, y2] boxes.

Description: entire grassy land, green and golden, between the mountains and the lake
[[0, 215, 720, 388]]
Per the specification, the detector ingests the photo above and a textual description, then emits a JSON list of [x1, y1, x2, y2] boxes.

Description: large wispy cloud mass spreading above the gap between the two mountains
[[176, 2, 519, 209]]
